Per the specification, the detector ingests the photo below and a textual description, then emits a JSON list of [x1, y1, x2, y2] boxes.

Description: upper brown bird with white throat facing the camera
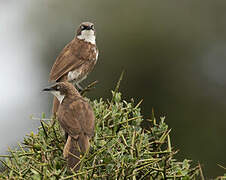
[[49, 22, 99, 115]]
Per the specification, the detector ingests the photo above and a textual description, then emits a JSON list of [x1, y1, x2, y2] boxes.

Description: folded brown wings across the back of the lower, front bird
[[59, 99, 95, 138]]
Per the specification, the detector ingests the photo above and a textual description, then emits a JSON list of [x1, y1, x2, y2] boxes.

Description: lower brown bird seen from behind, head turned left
[[43, 82, 95, 172]]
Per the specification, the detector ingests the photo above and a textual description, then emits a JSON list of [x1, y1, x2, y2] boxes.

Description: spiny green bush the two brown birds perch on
[[0, 91, 200, 180]]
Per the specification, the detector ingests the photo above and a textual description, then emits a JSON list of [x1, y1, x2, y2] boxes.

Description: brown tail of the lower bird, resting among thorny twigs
[[64, 134, 89, 171]]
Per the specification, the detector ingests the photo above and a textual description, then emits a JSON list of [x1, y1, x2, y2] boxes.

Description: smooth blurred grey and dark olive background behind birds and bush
[[0, 0, 226, 177]]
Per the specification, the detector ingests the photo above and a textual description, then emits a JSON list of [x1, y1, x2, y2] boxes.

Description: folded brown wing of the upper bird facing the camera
[[49, 39, 85, 81]]
